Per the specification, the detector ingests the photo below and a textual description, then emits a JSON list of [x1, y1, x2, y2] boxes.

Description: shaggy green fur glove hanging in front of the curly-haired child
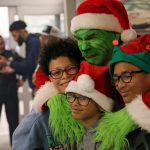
[[47, 94, 85, 144]]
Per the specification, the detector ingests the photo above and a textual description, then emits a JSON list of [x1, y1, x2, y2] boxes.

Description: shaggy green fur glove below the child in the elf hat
[[94, 108, 138, 150]]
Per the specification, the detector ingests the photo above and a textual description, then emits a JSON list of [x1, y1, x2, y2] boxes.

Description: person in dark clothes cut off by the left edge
[[0, 36, 23, 143]]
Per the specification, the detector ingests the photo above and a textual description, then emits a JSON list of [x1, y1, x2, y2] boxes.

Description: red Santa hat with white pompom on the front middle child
[[65, 62, 113, 111]]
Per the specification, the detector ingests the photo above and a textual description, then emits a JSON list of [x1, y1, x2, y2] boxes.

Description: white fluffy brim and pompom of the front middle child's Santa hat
[[65, 74, 113, 111]]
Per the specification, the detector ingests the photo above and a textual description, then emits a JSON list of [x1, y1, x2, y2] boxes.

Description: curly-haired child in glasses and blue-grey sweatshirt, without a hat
[[13, 39, 83, 150]]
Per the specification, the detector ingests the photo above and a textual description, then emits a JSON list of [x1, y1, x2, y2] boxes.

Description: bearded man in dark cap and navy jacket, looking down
[[0, 20, 41, 89]]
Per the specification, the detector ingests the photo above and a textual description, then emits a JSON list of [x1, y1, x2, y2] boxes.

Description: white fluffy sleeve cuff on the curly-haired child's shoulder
[[33, 81, 58, 112]]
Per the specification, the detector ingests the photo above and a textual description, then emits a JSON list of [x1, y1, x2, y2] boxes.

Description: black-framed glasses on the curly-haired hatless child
[[49, 66, 78, 79]]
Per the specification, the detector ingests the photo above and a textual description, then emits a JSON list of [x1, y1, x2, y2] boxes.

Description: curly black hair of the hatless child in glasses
[[39, 38, 84, 75]]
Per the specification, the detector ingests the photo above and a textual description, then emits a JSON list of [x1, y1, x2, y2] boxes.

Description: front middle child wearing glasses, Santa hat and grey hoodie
[[65, 67, 113, 150]]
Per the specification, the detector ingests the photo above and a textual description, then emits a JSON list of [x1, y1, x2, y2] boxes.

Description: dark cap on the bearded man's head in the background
[[9, 20, 27, 32]]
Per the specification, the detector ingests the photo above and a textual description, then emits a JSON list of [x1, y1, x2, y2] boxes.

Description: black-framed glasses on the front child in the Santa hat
[[66, 92, 91, 106]]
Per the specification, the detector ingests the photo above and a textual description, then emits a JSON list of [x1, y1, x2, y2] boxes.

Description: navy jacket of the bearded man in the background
[[11, 34, 41, 89]]
